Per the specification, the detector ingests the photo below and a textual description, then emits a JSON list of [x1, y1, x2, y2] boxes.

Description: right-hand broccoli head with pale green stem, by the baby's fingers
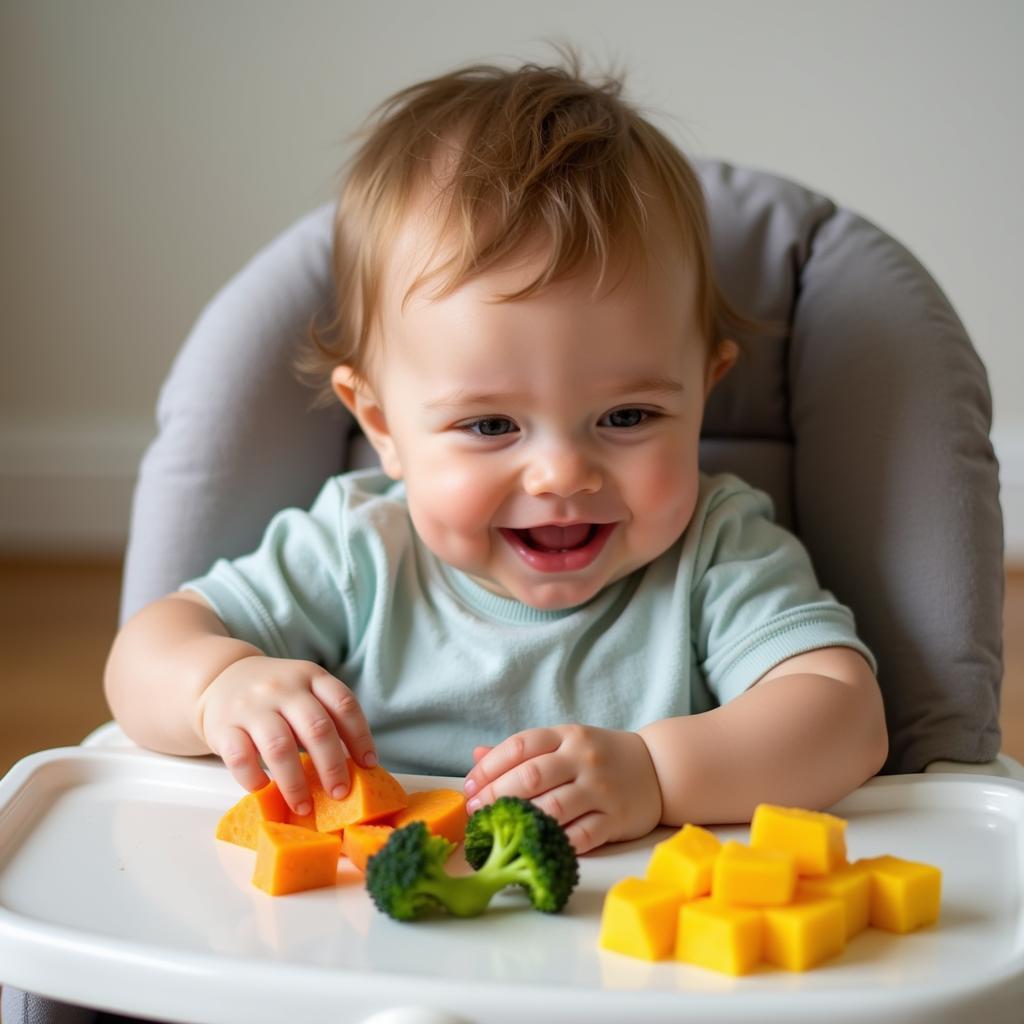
[[466, 797, 580, 913]]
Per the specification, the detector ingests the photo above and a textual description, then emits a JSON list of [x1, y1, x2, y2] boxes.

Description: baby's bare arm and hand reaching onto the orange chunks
[[103, 592, 376, 814]]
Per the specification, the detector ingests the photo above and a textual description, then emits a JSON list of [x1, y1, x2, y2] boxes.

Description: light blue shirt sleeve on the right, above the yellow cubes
[[690, 478, 878, 705]]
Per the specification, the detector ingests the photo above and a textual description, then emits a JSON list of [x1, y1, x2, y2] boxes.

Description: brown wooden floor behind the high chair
[[0, 560, 1024, 775]]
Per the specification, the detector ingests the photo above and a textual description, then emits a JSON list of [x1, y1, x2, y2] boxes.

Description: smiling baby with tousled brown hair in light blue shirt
[[105, 61, 887, 852]]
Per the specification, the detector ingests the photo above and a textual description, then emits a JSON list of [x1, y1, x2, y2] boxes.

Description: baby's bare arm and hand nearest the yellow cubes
[[466, 647, 888, 853]]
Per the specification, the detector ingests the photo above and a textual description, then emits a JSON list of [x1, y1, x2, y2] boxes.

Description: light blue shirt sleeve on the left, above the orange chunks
[[181, 478, 364, 668]]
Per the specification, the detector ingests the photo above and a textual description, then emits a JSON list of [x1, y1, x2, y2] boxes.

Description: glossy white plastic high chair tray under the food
[[0, 748, 1024, 1024]]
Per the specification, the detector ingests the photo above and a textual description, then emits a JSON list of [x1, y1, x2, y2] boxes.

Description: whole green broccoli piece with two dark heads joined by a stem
[[367, 797, 579, 921]]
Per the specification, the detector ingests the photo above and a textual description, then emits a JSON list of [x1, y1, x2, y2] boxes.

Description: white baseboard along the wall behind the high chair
[[0, 419, 1024, 565]]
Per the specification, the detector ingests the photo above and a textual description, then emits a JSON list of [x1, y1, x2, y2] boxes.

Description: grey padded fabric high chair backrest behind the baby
[[122, 162, 1002, 772]]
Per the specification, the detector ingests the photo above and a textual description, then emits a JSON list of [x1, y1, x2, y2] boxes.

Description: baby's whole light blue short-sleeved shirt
[[184, 469, 876, 775]]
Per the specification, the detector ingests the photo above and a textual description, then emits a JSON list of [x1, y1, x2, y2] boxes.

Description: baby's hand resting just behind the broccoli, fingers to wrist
[[464, 725, 662, 853]]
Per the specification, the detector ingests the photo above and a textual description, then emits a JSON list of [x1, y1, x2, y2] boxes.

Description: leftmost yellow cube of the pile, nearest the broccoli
[[598, 878, 683, 961]]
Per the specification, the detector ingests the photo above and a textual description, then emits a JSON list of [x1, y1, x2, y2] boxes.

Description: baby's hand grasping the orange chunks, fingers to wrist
[[197, 656, 377, 814]]
